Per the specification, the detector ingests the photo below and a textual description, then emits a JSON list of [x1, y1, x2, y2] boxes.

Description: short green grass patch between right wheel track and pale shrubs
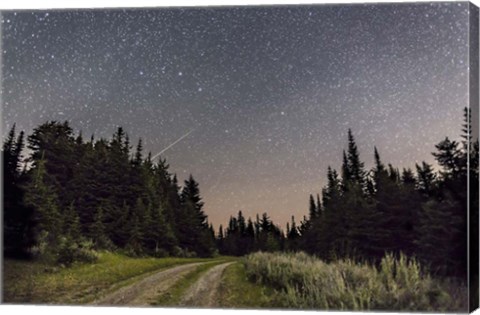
[[219, 263, 278, 308]]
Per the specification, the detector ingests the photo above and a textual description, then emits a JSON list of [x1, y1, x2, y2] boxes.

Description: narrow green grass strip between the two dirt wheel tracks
[[152, 259, 231, 306]]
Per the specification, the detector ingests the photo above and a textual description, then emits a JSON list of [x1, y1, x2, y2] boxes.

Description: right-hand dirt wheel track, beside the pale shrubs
[[179, 262, 234, 307]]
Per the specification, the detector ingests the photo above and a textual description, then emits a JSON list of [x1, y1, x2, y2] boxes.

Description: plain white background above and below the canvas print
[[0, 0, 480, 315]]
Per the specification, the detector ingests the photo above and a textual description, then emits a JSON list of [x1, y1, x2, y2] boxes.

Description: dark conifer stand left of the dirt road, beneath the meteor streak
[[2, 121, 216, 257]]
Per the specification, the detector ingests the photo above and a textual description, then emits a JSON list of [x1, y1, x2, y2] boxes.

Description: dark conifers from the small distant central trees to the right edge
[[217, 108, 479, 277]]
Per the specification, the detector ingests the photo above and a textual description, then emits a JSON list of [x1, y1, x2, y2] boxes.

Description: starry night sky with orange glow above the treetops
[[1, 2, 469, 227]]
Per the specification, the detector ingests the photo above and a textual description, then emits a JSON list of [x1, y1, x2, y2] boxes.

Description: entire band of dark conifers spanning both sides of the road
[[2, 109, 479, 279]]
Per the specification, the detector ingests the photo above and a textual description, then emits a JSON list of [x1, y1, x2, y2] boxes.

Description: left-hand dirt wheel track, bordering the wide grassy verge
[[92, 263, 204, 306]]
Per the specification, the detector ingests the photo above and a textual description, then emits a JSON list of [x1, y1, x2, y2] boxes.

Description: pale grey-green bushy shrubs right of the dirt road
[[244, 253, 467, 312]]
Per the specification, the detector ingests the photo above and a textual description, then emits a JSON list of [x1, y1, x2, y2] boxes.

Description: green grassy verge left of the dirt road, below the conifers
[[3, 252, 215, 304]]
